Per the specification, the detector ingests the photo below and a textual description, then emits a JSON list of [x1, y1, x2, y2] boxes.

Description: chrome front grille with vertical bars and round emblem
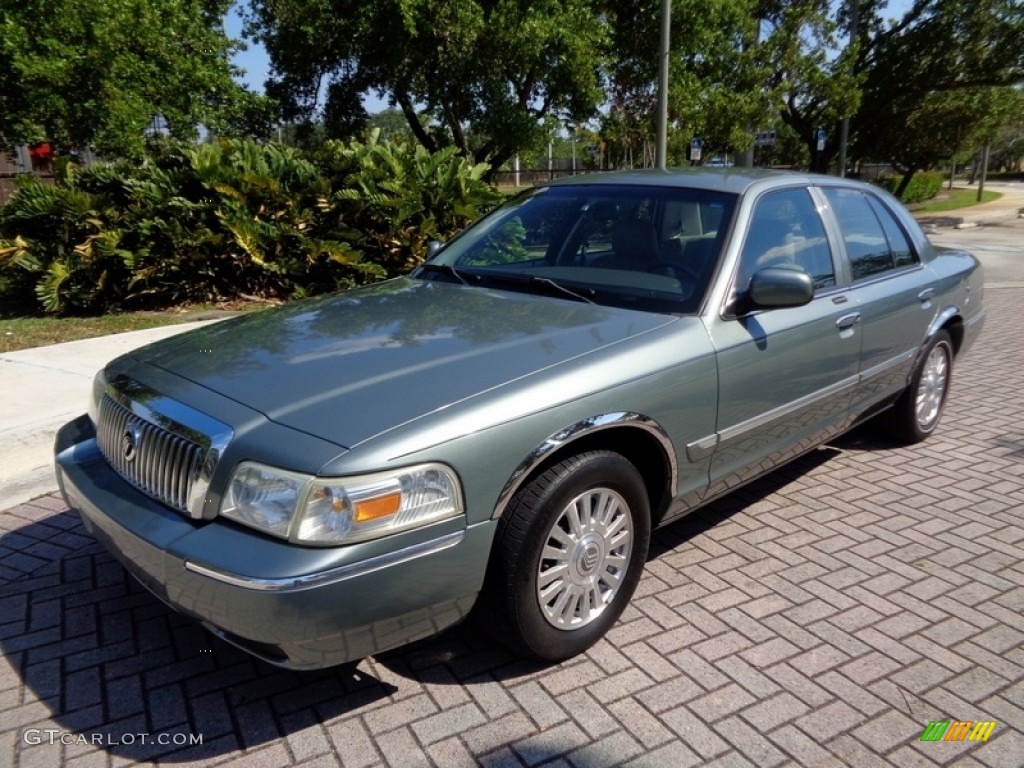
[[96, 394, 204, 515]]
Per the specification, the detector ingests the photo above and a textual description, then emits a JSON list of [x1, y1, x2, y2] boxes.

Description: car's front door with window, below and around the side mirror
[[709, 187, 861, 493]]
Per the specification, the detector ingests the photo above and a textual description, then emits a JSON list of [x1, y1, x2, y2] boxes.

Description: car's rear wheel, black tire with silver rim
[[882, 331, 953, 445]]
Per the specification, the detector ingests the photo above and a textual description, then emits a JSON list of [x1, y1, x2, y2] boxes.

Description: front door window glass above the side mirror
[[735, 189, 836, 295]]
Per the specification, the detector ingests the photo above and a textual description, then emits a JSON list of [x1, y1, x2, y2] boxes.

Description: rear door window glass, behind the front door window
[[823, 186, 916, 281]]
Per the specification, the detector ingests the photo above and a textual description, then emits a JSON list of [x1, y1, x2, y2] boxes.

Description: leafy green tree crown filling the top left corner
[[0, 0, 268, 156]]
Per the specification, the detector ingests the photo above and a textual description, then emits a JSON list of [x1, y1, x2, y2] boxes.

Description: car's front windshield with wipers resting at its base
[[414, 184, 735, 312]]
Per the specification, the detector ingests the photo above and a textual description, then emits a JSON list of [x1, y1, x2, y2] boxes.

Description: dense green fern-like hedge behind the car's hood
[[0, 138, 497, 312]]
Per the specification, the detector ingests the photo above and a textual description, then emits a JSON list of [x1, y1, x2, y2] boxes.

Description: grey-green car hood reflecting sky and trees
[[131, 279, 675, 449]]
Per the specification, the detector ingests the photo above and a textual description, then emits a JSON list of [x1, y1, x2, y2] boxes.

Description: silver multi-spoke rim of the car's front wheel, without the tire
[[537, 488, 633, 630]]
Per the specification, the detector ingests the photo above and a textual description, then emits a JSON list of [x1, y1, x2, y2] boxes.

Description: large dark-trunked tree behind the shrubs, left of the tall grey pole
[[241, 0, 608, 174]]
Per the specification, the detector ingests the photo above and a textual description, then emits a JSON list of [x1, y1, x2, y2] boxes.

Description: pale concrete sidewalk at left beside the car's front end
[[0, 321, 224, 511]]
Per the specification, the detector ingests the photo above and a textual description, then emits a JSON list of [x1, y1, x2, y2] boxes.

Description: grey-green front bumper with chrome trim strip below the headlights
[[55, 417, 495, 669]]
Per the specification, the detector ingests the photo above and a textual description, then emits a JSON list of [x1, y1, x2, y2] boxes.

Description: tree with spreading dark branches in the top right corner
[[769, 0, 1024, 169]]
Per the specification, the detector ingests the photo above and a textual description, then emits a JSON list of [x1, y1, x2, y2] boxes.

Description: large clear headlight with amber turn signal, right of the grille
[[220, 462, 463, 545]]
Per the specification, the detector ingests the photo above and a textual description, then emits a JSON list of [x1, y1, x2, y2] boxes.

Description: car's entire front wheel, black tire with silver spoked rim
[[481, 451, 650, 662]]
